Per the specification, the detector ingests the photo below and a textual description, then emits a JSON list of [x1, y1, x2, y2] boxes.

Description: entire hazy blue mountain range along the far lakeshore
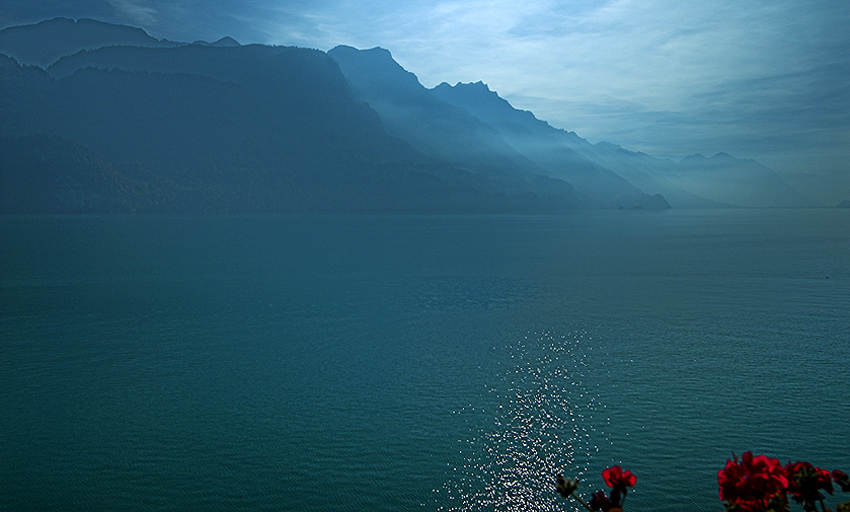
[[0, 18, 817, 213]]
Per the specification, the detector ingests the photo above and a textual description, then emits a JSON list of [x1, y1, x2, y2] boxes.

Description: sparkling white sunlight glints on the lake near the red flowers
[[435, 332, 607, 512]]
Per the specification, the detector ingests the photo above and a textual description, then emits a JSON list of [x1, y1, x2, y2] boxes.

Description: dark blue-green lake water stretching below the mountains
[[0, 210, 850, 512]]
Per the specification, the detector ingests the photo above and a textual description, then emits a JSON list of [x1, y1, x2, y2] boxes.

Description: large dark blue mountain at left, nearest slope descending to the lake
[[0, 30, 572, 212]]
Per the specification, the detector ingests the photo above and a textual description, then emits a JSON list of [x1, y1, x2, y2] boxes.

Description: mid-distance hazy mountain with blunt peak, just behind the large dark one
[[328, 46, 669, 209]]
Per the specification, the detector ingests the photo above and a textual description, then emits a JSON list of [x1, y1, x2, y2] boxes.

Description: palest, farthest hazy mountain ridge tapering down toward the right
[[434, 82, 818, 208]]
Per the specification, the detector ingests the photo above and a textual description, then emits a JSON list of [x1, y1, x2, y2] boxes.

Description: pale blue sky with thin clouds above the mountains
[[0, 0, 850, 180]]
